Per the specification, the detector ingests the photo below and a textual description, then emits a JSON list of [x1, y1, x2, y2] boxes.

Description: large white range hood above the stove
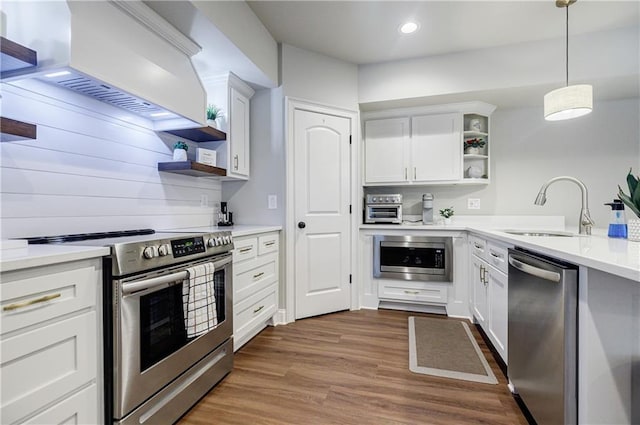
[[2, 0, 206, 130]]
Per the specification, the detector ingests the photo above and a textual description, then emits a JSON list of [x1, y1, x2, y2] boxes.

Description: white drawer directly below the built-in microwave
[[378, 281, 448, 304]]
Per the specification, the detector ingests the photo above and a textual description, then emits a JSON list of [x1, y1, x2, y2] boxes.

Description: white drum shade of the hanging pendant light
[[544, 84, 593, 121]]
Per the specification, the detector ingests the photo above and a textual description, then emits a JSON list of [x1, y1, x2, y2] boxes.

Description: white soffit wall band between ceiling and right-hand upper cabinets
[[358, 26, 640, 103]]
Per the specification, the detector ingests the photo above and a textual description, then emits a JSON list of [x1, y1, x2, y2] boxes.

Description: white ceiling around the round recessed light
[[247, 0, 640, 64]]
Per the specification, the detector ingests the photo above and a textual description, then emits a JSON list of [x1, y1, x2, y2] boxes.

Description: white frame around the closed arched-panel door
[[280, 96, 360, 323]]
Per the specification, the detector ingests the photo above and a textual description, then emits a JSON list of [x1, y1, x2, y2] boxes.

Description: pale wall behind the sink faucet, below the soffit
[[367, 98, 640, 228]]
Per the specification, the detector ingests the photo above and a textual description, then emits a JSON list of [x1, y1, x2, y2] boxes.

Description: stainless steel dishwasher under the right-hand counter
[[507, 249, 578, 425]]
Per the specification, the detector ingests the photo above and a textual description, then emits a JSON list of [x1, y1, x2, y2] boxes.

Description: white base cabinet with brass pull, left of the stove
[[0, 259, 102, 423]]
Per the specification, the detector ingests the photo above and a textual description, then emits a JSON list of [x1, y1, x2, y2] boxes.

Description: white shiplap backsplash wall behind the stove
[[0, 82, 221, 238]]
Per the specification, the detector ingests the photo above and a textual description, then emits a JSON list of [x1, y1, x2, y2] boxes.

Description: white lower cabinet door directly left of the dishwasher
[[488, 267, 508, 363]]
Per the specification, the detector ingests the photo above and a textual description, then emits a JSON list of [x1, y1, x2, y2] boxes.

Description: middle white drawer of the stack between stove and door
[[233, 254, 278, 304]]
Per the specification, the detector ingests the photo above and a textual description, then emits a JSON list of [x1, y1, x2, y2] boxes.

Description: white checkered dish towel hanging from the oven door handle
[[182, 263, 218, 338]]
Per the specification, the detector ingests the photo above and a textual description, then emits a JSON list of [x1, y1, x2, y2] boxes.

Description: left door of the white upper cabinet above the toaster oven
[[364, 118, 410, 184]]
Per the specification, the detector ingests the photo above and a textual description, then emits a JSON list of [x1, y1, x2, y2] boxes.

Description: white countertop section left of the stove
[[0, 245, 111, 272]]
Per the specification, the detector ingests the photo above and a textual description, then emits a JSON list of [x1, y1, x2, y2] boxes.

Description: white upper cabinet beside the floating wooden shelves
[[202, 72, 254, 180]]
